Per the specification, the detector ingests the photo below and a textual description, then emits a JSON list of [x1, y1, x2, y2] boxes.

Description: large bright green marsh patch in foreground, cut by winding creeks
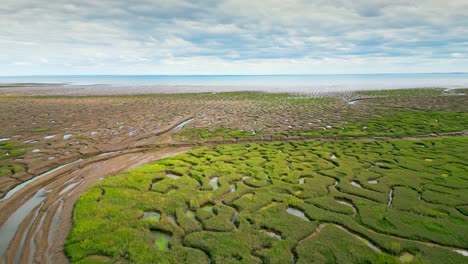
[[65, 137, 468, 263]]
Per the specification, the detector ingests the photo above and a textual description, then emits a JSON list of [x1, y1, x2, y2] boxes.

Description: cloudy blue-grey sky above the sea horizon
[[0, 0, 468, 76]]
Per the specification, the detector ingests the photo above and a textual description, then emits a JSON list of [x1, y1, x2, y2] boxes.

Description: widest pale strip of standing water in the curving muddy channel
[[0, 188, 47, 256]]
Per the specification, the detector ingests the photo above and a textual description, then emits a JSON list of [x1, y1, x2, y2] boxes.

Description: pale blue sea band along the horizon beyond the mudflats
[[0, 73, 468, 93]]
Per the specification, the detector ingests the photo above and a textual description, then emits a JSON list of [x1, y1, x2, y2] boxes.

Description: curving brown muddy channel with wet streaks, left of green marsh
[[0, 147, 191, 263]]
